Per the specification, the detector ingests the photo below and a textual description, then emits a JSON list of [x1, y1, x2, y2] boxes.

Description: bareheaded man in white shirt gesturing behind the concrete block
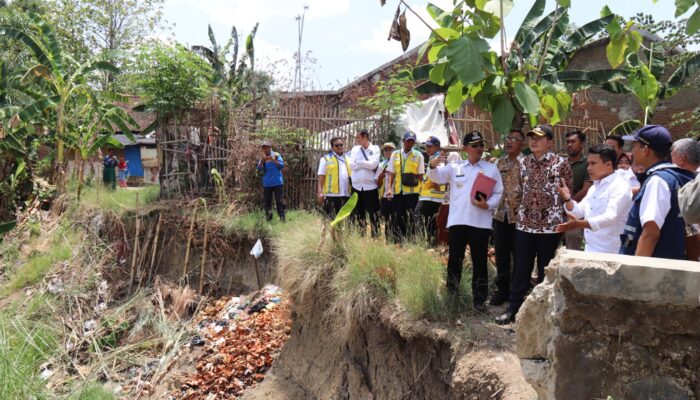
[[556, 144, 632, 254]]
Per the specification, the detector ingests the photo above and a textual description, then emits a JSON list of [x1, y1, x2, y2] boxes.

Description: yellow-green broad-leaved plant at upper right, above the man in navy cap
[[603, 7, 700, 133]]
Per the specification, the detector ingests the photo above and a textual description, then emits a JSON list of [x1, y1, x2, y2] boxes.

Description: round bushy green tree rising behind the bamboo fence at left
[[134, 42, 213, 118]]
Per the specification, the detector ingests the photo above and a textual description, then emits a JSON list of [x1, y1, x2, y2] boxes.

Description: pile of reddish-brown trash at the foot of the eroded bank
[[179, 285, 292, 399]]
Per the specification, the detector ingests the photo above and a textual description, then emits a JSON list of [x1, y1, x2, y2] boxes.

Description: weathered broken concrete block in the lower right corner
[[516, 251, 700, 400]]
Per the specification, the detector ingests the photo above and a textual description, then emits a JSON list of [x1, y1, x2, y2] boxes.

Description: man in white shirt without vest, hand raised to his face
[[350, 129, 379, 237]]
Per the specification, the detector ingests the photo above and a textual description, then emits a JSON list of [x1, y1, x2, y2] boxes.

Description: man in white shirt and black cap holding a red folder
[[428, 131, 503, 312]]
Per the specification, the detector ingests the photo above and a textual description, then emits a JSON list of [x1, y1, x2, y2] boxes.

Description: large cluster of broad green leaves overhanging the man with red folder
[[413, 0, 623, 134]]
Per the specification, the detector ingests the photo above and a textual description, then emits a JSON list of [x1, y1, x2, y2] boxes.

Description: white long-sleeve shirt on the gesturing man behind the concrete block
[[566, 173, 632, 254]]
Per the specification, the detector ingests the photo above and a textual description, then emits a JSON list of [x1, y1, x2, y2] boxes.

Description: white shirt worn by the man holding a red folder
[[428, 161, 503, 229]]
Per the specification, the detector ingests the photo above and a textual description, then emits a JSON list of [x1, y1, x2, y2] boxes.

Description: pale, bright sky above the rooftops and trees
[[164, 0, 675, 90]]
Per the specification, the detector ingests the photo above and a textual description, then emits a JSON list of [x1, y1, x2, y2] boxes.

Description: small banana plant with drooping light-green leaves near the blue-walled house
[[60, 99, 138, 200]]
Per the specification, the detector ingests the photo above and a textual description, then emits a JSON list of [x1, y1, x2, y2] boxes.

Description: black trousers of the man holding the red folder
[[447, 225, 491, 304]]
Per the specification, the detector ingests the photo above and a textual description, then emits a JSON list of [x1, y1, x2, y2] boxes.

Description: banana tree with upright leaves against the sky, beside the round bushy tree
[[192, 23, 259, 136]]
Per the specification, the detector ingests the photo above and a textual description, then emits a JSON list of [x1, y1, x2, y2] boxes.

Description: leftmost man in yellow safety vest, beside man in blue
[[316, 137, 352, 219]]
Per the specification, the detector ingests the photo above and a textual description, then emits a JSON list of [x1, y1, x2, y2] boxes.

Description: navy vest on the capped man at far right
[[620, 164, 694, 260]]
